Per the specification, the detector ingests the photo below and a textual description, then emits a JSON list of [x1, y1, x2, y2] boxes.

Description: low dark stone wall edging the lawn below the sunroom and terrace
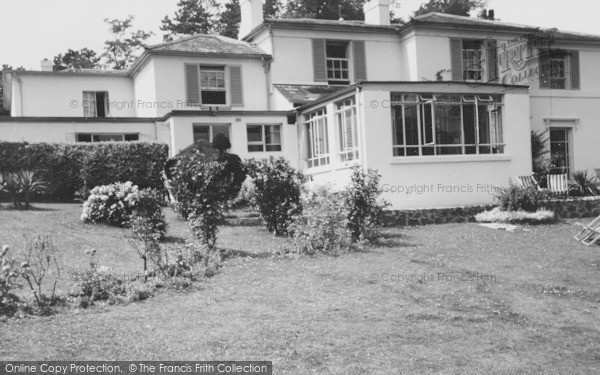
[[383, 197, 600, 227]]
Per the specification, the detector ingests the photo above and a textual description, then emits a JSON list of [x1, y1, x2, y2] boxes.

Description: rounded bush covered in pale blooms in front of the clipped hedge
[[81, 181, 140, 227]]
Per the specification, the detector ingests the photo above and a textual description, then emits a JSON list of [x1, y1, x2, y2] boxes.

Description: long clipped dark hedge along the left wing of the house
[[0, 142, 169, 202]]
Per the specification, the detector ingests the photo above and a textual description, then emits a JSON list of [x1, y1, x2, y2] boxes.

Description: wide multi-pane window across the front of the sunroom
[[392, 93, 504, 157]]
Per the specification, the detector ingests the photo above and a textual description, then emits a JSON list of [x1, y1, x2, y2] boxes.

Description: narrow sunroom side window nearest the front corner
[[336, 98, 359, 162]]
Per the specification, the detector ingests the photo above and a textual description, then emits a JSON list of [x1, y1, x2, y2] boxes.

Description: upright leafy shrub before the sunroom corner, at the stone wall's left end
[[345, 165, 387, 242]]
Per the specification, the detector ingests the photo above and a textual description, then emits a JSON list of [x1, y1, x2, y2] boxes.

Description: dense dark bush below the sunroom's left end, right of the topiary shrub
[[247, 156, 307, 236]]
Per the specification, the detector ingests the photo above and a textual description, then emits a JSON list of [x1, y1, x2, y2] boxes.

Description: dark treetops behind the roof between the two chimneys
[[284, 0, 365, 21]]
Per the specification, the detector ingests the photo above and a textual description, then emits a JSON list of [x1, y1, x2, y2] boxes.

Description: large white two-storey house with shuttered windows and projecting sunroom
[[0, 0, 600, 209]]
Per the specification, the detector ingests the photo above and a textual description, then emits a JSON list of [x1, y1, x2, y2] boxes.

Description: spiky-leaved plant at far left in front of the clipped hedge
[[0, 170, 48, 209]]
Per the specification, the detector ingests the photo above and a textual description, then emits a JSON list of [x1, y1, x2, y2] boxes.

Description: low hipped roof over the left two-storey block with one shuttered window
[[146, 34, 269, 57]]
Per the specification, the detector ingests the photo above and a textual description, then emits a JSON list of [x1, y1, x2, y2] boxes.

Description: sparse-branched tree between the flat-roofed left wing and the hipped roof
[[102, 16, 153, 70]]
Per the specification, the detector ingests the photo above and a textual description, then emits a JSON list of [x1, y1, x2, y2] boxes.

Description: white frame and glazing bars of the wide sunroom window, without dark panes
[[391, 93, 506, 158]]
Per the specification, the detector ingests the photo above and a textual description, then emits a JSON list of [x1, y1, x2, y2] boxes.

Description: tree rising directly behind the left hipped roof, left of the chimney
[[160, 0, 219, 41]]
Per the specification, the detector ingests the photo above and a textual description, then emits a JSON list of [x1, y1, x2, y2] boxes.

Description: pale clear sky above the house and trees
[[0, 0, 600, 70]]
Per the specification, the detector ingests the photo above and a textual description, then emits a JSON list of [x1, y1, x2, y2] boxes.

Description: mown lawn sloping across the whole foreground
[[0, 205, 600, 374]]
